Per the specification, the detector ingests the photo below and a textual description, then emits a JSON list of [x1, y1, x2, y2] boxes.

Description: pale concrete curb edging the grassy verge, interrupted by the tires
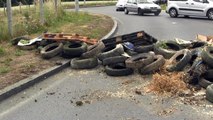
[[0, 17, 118, 102]]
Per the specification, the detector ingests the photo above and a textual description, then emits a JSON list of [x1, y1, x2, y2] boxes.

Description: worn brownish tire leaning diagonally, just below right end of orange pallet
[[82, 42, 105, 58]]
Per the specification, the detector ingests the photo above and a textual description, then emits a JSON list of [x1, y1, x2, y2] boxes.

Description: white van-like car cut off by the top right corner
[[166, 0, 213, 20]]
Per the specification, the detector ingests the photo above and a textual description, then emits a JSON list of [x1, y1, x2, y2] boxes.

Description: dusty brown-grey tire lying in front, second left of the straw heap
[[125, 53, 154, 68]]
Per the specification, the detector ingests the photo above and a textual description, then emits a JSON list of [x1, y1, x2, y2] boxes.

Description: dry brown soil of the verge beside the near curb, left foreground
[[0, 43, 55, 89]]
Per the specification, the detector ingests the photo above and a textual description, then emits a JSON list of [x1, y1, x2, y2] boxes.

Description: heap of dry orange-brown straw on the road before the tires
[[146, 60, 188, 95]]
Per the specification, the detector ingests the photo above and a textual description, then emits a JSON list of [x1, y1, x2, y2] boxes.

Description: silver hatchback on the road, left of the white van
[[124, 0, 161, 16]]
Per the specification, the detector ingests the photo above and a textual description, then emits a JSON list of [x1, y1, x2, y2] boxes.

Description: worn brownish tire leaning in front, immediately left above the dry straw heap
[[139, 55, 166, 75]]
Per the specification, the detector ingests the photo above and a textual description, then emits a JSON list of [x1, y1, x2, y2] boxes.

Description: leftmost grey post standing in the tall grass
[[7, 0, 13, 37]]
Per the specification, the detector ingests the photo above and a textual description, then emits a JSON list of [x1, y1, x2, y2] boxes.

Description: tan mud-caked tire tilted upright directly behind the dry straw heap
[[166, 49, 192, 72]]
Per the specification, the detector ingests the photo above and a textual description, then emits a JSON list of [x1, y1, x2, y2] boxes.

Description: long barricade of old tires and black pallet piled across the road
[[13, 32, 213, 102]]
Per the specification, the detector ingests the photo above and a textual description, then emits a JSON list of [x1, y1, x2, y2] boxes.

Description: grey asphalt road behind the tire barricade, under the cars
[[82, 6, 213, 40]]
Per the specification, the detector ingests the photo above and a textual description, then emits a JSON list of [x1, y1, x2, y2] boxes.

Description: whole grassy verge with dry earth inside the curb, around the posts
[[0, 2, 113, 89]]
